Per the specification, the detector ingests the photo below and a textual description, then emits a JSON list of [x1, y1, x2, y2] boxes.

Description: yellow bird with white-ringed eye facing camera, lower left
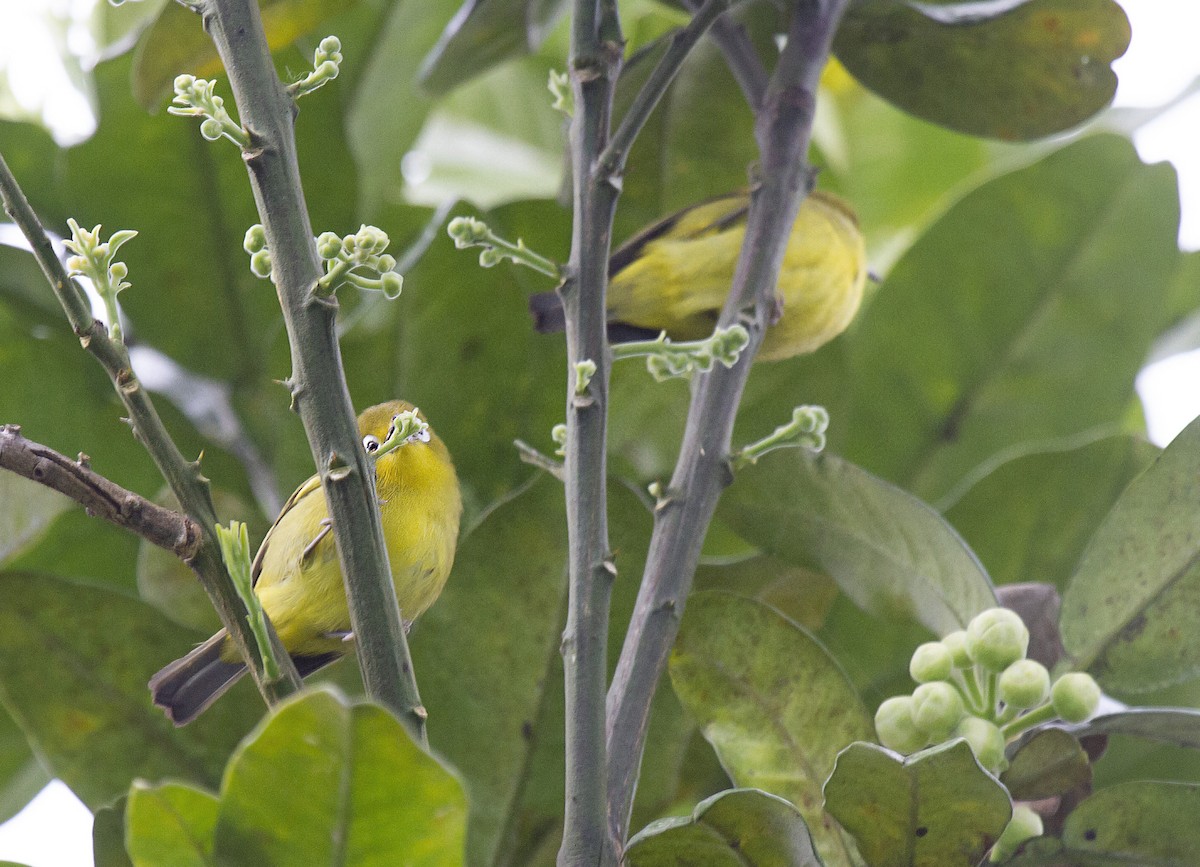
[[150, 400, 462, 725]]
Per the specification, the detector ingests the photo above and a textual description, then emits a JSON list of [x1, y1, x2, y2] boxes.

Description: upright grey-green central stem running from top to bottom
[[558, 0, 624, 867]]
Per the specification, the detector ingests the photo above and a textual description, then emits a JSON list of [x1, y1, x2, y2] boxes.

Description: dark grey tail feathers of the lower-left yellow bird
[[150, 629, 341, 725]]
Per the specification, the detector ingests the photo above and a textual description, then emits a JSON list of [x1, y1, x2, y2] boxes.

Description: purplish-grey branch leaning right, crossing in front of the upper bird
[[607, 0, 848, 839]]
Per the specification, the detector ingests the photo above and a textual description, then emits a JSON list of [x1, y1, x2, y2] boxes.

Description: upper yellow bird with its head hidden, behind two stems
[[529, 191, 866, 361]]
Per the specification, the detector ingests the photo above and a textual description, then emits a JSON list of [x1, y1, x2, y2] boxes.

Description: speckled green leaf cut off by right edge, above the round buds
[[1061, 419, 1200, 693]]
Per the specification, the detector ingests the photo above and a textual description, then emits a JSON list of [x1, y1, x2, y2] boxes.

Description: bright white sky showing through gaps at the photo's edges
[[0, 0, 1200, 867]]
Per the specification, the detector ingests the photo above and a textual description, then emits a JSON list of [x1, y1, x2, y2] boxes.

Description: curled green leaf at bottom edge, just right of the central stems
[[623, 789, 821, 867]]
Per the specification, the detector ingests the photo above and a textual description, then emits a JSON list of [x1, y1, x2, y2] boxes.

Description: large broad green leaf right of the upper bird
[[830, 136, 1178, 502]]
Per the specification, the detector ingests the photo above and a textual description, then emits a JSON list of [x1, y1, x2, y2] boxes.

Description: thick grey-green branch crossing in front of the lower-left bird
[[189, 0, 426, 742]]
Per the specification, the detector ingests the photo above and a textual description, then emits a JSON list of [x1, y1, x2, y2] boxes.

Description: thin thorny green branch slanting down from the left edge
[[0, 147, 300, 704]]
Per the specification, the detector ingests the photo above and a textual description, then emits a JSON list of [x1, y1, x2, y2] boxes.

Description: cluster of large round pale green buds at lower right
[[875, 608, 1100, 773]]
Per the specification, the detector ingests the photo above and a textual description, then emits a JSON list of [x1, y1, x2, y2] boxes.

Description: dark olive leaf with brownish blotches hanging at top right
[[834, 0, 1129, 140]]
